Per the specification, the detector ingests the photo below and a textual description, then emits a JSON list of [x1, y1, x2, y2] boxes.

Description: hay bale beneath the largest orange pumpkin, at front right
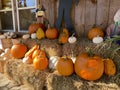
[[46, 73, 120, 90]]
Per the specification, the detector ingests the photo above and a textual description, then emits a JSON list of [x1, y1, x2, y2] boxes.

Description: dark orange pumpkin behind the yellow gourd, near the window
[[28, 23, 45, 34]]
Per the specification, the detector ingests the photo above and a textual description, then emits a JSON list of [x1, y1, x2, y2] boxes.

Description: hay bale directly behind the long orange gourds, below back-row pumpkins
[[22, 39, 62, 57]]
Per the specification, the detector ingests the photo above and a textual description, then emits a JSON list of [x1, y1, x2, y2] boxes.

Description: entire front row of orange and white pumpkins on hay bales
[[11, 44, 116, 81]]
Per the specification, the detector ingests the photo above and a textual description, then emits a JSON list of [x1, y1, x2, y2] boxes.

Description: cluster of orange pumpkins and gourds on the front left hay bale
[[11, 44, 48, 70]]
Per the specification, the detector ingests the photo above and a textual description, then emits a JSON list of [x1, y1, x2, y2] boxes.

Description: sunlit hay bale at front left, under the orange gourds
[[5, 59, 48, 90]]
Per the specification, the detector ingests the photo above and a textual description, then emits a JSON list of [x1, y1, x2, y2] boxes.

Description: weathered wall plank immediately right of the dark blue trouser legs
[[74, 0, 85, 37]]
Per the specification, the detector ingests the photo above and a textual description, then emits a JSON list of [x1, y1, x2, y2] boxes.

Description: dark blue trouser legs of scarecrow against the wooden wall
[[55, 0, 79, 35]]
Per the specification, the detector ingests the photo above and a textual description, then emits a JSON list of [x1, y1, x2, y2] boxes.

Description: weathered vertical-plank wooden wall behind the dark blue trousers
[[40, 0, 120, 36]]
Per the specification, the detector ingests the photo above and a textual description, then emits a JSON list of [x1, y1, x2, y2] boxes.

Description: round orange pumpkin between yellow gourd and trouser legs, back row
[[45, 26, 58, 39]]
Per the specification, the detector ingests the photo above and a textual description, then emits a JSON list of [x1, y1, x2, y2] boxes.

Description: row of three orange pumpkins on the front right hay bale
[[56, 52, 116, 81]]
